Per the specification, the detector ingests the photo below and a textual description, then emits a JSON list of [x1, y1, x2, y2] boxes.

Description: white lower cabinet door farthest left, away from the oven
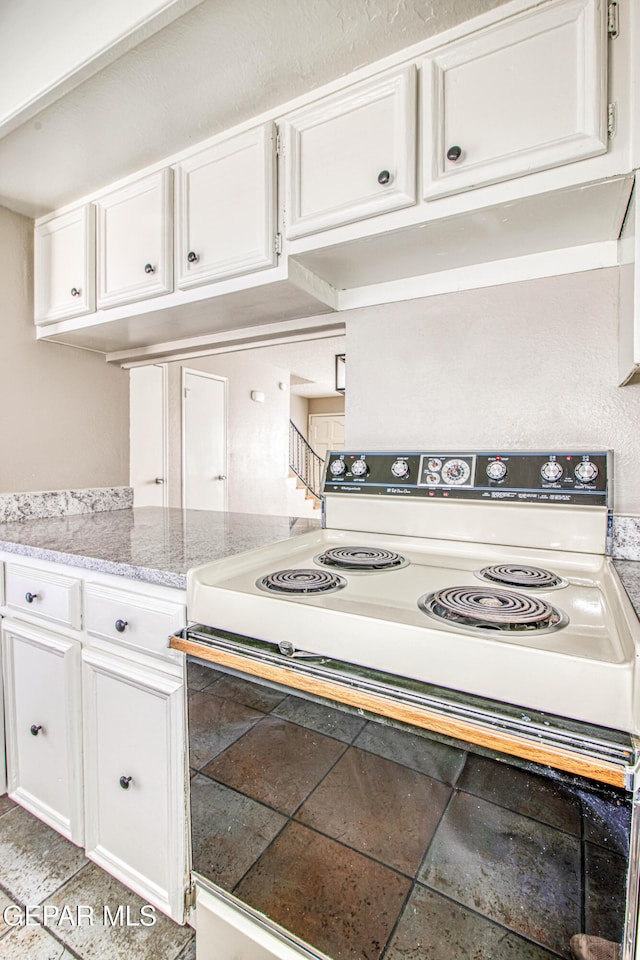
[[2, 620, 83, 844]]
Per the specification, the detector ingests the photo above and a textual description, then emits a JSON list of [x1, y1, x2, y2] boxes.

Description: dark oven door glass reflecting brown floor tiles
[[189, 663, 630, 960]]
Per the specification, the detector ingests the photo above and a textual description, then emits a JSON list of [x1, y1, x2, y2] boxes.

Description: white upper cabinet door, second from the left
[[97, 169, 173, 308]]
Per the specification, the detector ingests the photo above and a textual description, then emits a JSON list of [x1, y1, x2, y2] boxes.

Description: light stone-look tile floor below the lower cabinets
[[0, 796, 196, 960]]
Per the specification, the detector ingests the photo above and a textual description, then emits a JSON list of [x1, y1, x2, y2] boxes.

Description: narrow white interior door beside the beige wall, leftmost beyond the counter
[[129, 364, 168, 507]]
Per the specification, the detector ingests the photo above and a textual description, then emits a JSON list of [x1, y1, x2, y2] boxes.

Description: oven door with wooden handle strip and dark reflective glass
[[174, 628, 637, 960]]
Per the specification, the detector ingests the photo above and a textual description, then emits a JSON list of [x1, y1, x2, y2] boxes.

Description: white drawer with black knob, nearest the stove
[[86, 583, 186, 660]]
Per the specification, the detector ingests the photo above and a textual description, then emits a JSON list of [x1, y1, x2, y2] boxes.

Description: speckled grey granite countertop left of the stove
[[0, 507, 320, 589]]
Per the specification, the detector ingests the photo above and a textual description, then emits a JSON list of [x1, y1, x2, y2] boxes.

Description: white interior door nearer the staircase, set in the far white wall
[[182, 370, 227, 510]]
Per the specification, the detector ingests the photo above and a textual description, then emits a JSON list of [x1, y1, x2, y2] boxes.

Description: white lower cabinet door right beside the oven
[[83, 650, 187, 923]]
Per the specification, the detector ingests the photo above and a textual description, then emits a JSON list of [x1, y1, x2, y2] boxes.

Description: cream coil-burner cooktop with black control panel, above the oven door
[[188, 451, 640, 733]]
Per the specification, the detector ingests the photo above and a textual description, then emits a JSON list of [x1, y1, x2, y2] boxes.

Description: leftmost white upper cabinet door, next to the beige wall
[[34, 204, 96, 323]]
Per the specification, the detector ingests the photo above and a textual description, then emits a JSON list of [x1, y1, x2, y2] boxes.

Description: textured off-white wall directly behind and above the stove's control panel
[[346, 268, 640, 514]]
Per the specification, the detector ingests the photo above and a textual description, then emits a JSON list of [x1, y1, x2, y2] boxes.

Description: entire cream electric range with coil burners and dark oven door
[[178, 450, 640, 960]]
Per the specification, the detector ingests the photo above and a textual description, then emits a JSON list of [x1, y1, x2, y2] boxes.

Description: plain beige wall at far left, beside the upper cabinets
[[0, 207, 129, 493]]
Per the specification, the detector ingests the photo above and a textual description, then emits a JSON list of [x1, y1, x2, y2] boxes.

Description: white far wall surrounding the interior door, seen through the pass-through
[[168, 351, 289, 514]]
